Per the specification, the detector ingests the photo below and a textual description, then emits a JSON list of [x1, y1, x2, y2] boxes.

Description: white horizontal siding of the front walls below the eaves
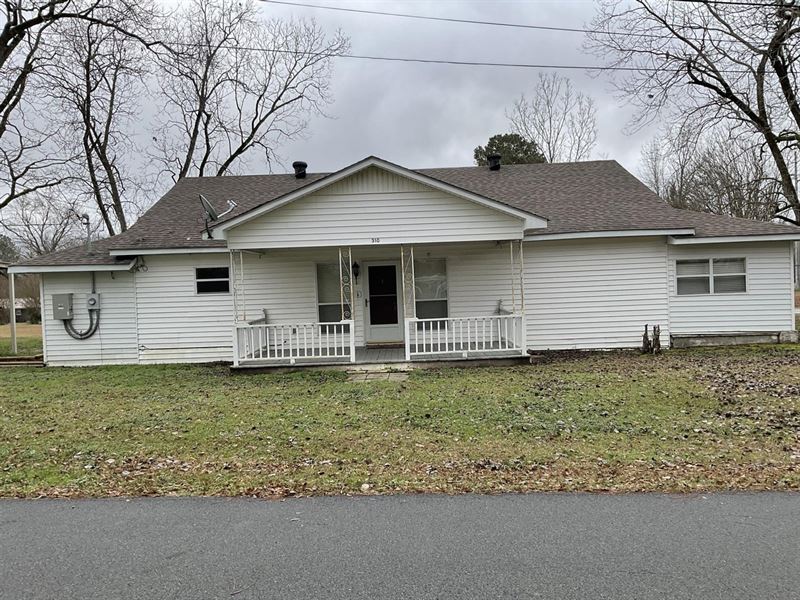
[[34, 238, 793, 365]]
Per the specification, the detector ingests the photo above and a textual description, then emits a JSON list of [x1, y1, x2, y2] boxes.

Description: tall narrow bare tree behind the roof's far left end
[[41, 13, 146, 235]]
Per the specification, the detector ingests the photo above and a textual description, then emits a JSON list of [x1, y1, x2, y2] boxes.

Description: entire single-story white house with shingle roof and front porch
[[10, 157, 800, 366]]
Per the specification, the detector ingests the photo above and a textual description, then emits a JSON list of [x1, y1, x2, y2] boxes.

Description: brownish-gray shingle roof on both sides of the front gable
[[15, 160, 800, 265]]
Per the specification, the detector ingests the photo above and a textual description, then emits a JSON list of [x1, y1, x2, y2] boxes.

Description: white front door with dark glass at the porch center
[[364, 263, 403, 344]]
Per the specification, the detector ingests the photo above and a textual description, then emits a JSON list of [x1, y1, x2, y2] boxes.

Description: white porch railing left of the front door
[[233, 320, 356, 367]]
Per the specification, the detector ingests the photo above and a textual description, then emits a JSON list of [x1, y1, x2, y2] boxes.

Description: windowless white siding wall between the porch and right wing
[[525, 237, 669, 350]]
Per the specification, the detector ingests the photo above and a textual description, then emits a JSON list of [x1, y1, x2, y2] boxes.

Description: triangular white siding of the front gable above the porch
[[227, 168, 524, 249]]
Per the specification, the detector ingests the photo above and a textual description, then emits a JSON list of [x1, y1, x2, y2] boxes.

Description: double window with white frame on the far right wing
[[675, 258, 747, 296]]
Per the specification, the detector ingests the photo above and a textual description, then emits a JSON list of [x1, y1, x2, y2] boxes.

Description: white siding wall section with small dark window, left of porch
[[136, 254, 233, 363]]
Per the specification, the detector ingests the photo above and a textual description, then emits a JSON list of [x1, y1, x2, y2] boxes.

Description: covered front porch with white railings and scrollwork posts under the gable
[[231, 241, 526, 368]]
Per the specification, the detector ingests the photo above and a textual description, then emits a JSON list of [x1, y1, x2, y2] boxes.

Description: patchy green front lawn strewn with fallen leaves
[[0, 346, 800, 497]]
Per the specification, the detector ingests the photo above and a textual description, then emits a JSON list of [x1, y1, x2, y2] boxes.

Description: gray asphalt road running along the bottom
[[0, 493, 800, 600]]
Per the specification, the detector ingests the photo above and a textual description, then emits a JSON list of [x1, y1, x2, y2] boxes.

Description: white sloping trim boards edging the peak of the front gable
[[211, 156, 547, 239]]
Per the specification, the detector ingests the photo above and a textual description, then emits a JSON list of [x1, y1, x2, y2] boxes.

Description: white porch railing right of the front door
[[405, 314, 525, 360]]
